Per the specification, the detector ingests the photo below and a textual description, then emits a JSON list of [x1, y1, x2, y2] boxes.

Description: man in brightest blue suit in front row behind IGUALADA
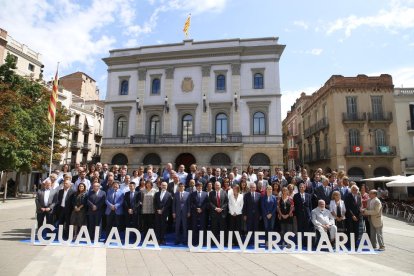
[[105, 181, 124, 237]]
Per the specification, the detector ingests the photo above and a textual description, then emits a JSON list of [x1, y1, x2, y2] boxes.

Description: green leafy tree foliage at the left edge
[[0, 52, 70, 171]]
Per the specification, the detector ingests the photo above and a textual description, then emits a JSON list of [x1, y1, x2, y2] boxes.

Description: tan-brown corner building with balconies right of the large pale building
[[285, 74, 401, 184]]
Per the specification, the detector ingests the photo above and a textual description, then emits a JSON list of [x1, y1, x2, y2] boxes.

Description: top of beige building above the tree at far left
[[0, 28, 44, 80]]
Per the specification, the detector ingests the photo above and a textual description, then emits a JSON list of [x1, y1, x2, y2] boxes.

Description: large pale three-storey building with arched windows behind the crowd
[[102, 38, 285, 168]]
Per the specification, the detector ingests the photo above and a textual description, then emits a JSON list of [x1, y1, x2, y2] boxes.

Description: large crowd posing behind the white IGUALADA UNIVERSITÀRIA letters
[[36, 163, 385, 250]]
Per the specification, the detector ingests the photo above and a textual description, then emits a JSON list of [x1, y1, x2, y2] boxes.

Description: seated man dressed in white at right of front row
[[312, 199, 337, 242]]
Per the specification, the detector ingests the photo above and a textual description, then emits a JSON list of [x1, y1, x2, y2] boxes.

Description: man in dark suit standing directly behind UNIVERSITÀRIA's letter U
[[190, 182, 208, 244]]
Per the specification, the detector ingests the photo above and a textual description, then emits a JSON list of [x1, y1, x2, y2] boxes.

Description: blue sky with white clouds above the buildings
[[0, 0, 414, 118]]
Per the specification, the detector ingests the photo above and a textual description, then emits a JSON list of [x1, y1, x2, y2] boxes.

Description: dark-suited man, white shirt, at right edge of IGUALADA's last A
[[154, 182, 172, 245]]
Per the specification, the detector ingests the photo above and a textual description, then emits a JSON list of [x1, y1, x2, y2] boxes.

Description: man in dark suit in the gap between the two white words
[[173, 182, 190, 244]]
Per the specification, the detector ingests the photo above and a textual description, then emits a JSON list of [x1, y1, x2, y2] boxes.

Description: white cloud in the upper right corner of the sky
[[326, 1, 414, 37]]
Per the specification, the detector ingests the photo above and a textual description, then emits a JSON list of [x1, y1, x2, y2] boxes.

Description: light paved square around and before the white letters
[[0, 199, 414, 276]]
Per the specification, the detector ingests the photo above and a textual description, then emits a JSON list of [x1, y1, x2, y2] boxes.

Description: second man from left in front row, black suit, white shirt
[[56, 180, 75, 238]]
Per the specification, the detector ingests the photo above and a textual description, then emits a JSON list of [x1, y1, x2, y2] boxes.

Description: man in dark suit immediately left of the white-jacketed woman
[[209, 181, 229, 240]]
